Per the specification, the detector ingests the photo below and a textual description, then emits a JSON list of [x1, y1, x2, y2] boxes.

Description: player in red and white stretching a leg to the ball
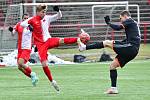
[[21, 5, 89, 91]]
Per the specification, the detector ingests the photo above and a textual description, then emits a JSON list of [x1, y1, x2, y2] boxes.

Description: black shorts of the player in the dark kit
[[113, 41, 138, 67]]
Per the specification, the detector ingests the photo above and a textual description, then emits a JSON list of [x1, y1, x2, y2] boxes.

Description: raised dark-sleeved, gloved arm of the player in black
[[104, 16, 124, 30]]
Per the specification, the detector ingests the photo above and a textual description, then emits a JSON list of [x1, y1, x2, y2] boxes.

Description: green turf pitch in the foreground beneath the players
[[0, 60, 150, 100]]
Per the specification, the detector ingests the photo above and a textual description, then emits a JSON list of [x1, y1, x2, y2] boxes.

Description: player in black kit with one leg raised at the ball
[[79, 11, 141, 94]]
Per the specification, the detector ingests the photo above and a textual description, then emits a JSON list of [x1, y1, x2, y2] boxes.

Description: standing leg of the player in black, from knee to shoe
[[105, 59, 120, 94]]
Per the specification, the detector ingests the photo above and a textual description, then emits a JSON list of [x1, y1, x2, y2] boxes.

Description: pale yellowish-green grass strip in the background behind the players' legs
[[49, 44, 150, 61]]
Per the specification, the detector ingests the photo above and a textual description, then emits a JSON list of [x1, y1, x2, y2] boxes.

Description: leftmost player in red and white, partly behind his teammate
[[9, 14, 38, 86]]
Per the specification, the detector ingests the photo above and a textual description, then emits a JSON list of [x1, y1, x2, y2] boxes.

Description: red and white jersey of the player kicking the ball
[[21, 11, 62, 43]]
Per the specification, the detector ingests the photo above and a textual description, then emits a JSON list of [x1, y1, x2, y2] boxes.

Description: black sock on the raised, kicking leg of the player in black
[[86, 42, 104, 50]]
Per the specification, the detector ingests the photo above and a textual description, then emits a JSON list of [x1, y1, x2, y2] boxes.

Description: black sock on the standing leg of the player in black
[[110, 70, 117, 87]]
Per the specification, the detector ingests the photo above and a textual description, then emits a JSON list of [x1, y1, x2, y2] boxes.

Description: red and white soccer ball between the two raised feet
[[79, 29, 90, 44]]
